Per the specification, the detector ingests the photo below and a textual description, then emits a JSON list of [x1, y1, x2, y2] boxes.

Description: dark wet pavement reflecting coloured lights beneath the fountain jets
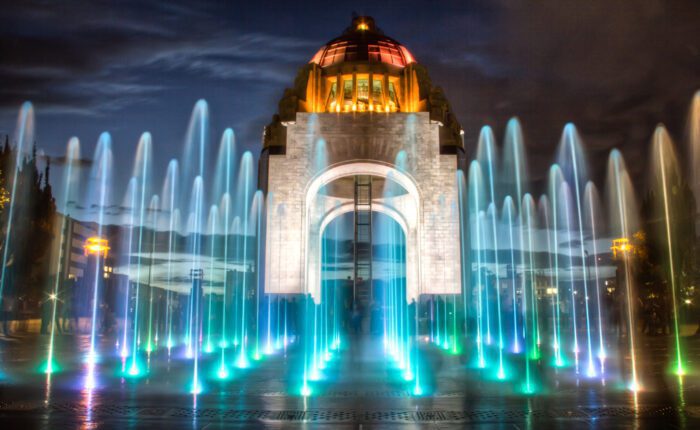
[[0, 335, 700, 430]]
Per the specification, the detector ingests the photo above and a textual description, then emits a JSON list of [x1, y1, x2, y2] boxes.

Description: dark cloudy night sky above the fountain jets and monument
[[0, 0, 700, 191]]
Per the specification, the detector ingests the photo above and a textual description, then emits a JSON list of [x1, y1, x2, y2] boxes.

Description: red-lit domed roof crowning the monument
[[311, 16, 416, 67]]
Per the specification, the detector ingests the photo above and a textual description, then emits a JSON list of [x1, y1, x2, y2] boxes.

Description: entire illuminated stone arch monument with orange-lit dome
[[259, 17, 464, 301]]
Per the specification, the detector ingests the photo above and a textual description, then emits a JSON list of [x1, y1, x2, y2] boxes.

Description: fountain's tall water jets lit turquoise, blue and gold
[[0, 83, 700, 404]]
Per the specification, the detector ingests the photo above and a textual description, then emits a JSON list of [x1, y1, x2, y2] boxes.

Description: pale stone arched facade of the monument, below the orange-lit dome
[[265, 112, 461, 300]]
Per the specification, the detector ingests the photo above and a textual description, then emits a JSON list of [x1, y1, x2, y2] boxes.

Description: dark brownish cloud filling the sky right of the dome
[[416, 0, 700, 185]]
